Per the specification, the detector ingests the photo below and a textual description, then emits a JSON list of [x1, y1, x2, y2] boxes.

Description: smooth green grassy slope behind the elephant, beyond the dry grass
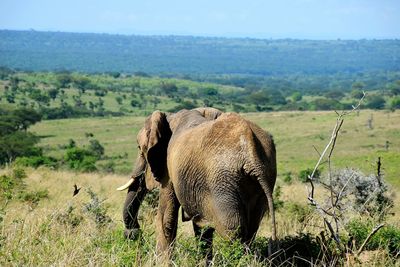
[[30, 110, 400, 189]]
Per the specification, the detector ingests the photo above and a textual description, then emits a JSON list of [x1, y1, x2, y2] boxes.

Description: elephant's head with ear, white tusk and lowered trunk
[[118, 111, 171, 238]]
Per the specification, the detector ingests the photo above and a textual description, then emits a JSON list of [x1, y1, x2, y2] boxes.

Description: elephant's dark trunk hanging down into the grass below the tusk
[[122, 174, 147, 239]]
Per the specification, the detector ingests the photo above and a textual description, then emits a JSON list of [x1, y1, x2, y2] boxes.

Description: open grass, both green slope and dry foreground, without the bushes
[[0, 110, 400, 266]]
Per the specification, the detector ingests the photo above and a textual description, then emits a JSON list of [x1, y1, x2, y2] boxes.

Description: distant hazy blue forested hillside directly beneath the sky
[[0, 30, 400, 75]]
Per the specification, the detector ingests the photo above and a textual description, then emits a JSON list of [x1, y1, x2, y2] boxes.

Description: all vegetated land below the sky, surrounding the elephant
[[0, 31, 400, 266]]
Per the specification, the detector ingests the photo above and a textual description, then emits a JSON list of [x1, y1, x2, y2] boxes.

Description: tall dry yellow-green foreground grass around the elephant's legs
[[0, 169, 396, 266]]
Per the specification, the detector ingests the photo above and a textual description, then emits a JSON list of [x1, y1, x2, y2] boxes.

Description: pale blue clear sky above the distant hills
[[0, 0, 400, 39]]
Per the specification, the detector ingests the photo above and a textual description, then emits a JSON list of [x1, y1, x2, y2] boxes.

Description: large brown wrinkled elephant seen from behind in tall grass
[[119, 108, 277, 259]]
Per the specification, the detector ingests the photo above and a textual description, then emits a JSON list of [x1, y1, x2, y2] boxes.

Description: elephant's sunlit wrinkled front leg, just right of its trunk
[[156, 183, 180, 256]]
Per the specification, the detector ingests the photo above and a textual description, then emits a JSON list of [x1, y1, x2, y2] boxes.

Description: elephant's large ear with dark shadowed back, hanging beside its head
[[147, 111, 171, 181]]
